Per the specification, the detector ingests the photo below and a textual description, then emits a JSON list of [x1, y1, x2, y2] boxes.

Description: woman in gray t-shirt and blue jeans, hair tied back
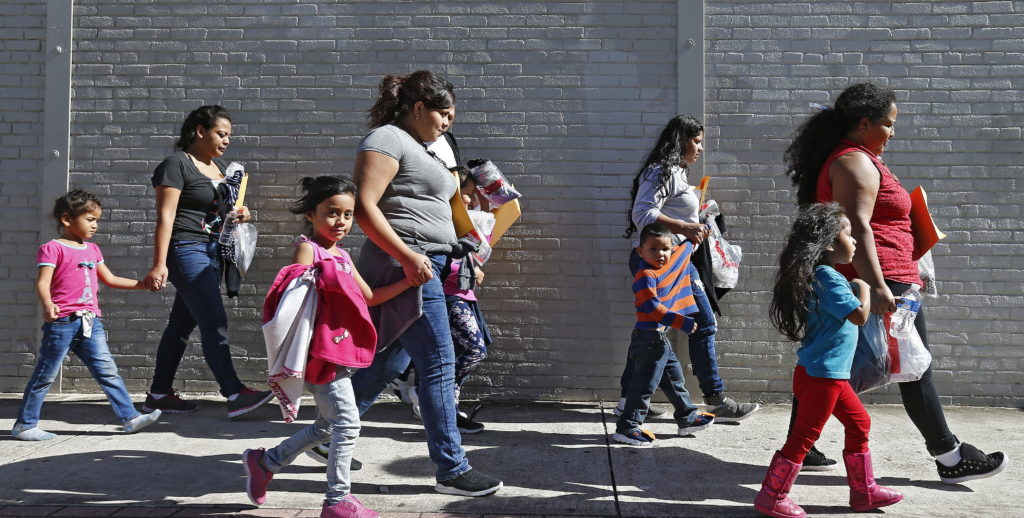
[[352, 71, 502, 497]]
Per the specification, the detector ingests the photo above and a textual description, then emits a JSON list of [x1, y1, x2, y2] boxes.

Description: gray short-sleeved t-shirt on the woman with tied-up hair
[[356, 124, 459, 245]]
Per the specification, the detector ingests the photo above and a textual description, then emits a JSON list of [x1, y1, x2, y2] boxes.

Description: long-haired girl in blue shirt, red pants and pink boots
[[754, 203, 903, 517]]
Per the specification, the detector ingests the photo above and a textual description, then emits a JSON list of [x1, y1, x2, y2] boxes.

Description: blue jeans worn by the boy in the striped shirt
[[615, 330, 697, 433]]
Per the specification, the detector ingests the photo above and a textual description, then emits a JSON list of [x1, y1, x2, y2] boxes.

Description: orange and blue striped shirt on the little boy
[[633, 241, 697, 332]]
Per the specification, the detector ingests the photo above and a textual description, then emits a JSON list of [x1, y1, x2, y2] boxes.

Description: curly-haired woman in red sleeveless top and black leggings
[[785, 83, 1007, 483]]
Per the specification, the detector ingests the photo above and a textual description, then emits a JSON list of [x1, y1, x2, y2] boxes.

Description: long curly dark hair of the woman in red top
[[783, 83, 896, 205]]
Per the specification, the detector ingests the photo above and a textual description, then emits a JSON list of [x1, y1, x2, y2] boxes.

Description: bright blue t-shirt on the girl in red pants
[[797, 265, 860, 380]]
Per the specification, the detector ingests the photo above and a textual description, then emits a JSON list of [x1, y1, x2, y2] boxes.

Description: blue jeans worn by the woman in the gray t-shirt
[[352, 255, 470, 480]]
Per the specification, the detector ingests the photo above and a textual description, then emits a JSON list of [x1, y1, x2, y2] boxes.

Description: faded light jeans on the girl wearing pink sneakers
[[263, 366, 359, 506]]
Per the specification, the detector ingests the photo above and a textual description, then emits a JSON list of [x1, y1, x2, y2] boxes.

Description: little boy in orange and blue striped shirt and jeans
[[611, 223, 715, 446]]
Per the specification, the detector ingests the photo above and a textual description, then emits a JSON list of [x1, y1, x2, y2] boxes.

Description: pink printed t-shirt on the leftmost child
[[36, 240, 103, 318]]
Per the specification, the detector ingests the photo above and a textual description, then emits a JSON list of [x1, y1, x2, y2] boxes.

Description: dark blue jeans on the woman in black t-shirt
[[150, 241, 245, 396]]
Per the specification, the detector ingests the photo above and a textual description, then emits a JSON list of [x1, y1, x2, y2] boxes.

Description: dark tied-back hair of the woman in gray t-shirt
[[367, 71, 455, 128]]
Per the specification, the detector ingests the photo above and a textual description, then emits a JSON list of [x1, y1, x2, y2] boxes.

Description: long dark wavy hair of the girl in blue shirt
[[768, 202, 846, 341]]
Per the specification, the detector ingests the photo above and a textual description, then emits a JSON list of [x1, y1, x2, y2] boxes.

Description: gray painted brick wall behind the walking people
[[0, 0, 1024, 411]]
